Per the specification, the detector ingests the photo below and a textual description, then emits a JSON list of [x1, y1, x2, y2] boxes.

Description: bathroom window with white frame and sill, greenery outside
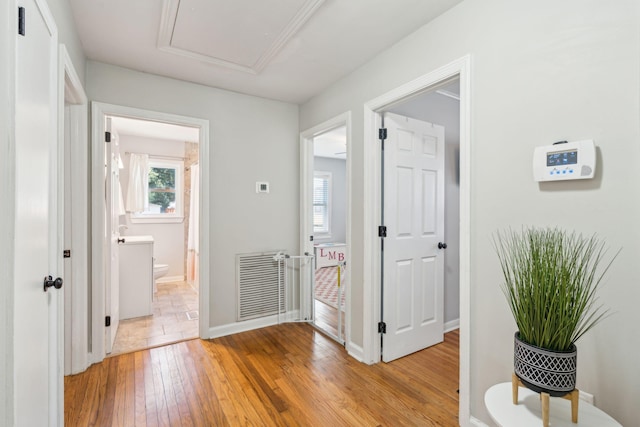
[[131, 157, 184, 223]]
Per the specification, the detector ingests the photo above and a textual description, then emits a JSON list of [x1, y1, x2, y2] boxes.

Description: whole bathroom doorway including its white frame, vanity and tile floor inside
[[91, 103, 209, 362]]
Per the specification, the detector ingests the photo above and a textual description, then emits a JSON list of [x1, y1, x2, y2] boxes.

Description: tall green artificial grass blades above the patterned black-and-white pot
[[494, 228, 617, 351]]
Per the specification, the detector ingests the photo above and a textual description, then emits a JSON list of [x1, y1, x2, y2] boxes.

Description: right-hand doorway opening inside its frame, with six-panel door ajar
[[381, 78, 460, 360]]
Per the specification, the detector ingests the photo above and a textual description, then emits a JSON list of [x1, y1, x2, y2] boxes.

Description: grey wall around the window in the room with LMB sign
[[313, 157, 347, 243]]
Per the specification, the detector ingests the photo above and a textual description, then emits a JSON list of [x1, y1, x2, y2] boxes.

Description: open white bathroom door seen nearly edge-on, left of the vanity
[[104, 117, 121, 354]]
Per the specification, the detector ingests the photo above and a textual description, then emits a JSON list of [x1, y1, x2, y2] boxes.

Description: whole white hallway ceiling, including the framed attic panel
[[70, 0, 462, 103]]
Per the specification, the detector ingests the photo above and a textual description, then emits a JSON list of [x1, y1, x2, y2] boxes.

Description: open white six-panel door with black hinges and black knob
[[382, 113, 444, 362]]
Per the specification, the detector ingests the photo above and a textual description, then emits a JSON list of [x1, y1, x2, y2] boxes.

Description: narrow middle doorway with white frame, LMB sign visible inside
[[301, 114, 351, 345]]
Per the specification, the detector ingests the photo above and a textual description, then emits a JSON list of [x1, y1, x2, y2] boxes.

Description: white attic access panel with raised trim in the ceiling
[[158, 0, 324, 74]]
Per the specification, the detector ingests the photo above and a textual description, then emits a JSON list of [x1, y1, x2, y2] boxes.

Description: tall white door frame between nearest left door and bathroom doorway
[[58, 44, 89, 375]]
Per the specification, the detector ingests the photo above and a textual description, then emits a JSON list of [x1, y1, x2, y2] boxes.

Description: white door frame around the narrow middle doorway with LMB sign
[[300, 111, 352, 355]]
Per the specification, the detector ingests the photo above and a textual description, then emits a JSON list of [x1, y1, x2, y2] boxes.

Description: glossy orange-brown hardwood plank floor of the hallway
[[65, 324, 459, 427]]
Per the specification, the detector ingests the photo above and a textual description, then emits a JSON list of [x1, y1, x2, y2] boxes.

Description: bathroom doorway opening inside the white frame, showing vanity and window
[[107, 116, 199, 355]]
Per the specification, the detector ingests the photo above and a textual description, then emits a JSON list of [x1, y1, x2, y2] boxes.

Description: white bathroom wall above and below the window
[[120, 135, 189, 277]]
